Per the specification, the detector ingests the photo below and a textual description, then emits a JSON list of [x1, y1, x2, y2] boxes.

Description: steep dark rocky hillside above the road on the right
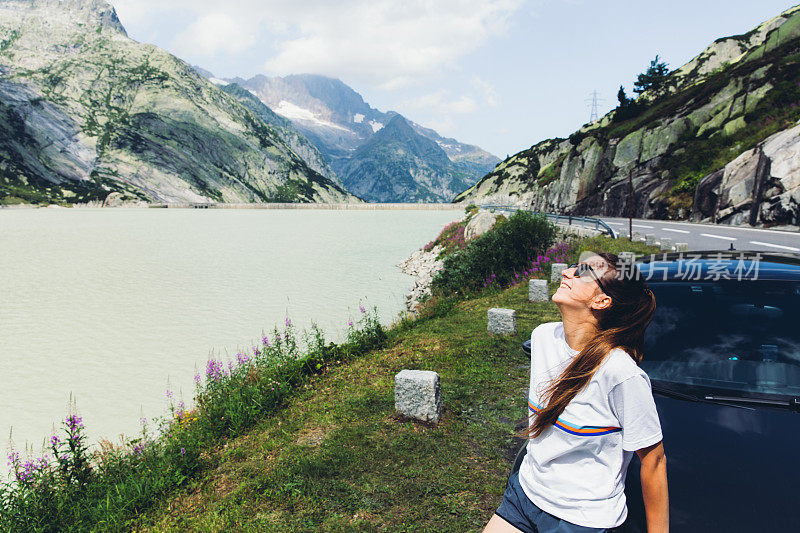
[[456, 7, 800, 229]]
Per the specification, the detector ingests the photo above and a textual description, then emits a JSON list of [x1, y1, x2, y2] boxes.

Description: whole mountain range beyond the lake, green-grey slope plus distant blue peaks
[[0, 0, 498, 205]]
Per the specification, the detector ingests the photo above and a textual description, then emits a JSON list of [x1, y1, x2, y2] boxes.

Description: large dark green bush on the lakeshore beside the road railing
[[431, 211, 556, 296]]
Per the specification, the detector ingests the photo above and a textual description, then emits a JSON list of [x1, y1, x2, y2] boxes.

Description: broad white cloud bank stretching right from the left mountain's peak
[[114, 0, 524, 89]]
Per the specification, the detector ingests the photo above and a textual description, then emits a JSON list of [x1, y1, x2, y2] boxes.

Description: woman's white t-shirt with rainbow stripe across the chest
[[519, 322, 662, 528]]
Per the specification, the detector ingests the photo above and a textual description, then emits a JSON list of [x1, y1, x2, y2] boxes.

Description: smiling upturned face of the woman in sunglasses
[[552, 255, 611, 315]]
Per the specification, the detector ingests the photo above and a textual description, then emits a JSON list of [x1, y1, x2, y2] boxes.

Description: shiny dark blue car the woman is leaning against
[[515, 251, 800, 533]]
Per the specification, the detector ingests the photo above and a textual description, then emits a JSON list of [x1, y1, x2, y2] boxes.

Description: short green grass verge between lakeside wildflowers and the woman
[[138, 239, 655, 531]]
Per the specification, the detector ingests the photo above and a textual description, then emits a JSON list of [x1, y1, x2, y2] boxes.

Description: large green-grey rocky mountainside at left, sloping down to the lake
[[0, 0, 355, 203]]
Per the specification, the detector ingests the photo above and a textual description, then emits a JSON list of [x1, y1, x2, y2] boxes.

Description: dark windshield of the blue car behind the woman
[[642, 280, 800, 397]]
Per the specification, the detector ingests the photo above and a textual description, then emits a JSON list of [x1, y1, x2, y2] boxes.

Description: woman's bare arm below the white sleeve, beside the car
[[636, 442, 669, 533]]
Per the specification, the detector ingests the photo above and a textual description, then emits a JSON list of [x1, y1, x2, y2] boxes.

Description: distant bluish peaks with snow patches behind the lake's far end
[[202, 71, 500, 202]]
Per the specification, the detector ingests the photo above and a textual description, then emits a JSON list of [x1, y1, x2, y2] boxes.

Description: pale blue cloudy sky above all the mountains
[[111, 0, 797, 158]]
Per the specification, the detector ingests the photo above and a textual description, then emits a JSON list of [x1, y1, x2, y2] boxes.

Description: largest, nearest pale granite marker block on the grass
[[394, 370, 442, 424]]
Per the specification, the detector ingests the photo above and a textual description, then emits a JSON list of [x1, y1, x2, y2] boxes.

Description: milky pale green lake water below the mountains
[[0, 209, 463, 453]]
